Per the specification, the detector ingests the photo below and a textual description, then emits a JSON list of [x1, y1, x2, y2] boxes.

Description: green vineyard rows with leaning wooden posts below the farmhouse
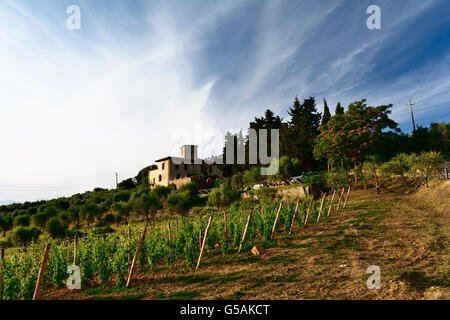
[[1, 189, 344, 300]]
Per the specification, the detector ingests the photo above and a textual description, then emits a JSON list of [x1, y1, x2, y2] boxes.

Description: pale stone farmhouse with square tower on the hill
[[148, 145, 222, 188]]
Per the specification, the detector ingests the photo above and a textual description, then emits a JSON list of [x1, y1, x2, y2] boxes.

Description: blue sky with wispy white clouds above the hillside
[[0, 0, 450, 204]]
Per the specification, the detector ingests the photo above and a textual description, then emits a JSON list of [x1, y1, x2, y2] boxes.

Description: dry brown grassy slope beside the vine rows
[[42, 181, 450, 300]]
